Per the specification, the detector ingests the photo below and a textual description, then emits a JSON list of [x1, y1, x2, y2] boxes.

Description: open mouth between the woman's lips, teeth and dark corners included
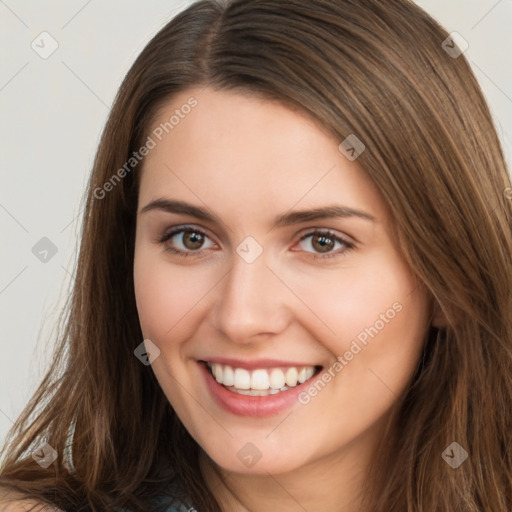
[[205, 361, 322, 396]]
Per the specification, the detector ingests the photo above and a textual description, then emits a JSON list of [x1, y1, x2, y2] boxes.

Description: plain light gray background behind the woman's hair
[[0, 0, 512, 454]]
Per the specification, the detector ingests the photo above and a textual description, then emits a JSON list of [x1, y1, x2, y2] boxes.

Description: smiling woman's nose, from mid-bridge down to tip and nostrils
[[214, 249, 293, 344]]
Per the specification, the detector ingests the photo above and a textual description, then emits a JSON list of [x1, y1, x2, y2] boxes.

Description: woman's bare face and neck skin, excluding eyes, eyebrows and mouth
[[134, 88, 438, 512]]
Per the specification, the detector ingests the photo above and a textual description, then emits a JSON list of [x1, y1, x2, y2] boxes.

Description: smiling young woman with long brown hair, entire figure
[[0, 0, 512, 512]]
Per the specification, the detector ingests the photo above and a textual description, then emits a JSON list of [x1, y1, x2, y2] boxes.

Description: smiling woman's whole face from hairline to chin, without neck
[[134, 89, 430, 474]]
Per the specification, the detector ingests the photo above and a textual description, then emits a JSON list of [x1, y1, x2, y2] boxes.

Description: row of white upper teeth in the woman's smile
[[208, 363, 315, 390]]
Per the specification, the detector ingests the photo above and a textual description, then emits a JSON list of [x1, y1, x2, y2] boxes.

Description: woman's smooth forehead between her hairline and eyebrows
[[136, 88, 385, 224]]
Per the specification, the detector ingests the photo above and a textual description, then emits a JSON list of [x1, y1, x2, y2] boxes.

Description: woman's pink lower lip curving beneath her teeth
[[199, 362, 317, 418]]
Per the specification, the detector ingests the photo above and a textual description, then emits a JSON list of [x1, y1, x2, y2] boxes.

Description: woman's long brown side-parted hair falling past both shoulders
[[0, 0, 512, 512]]
